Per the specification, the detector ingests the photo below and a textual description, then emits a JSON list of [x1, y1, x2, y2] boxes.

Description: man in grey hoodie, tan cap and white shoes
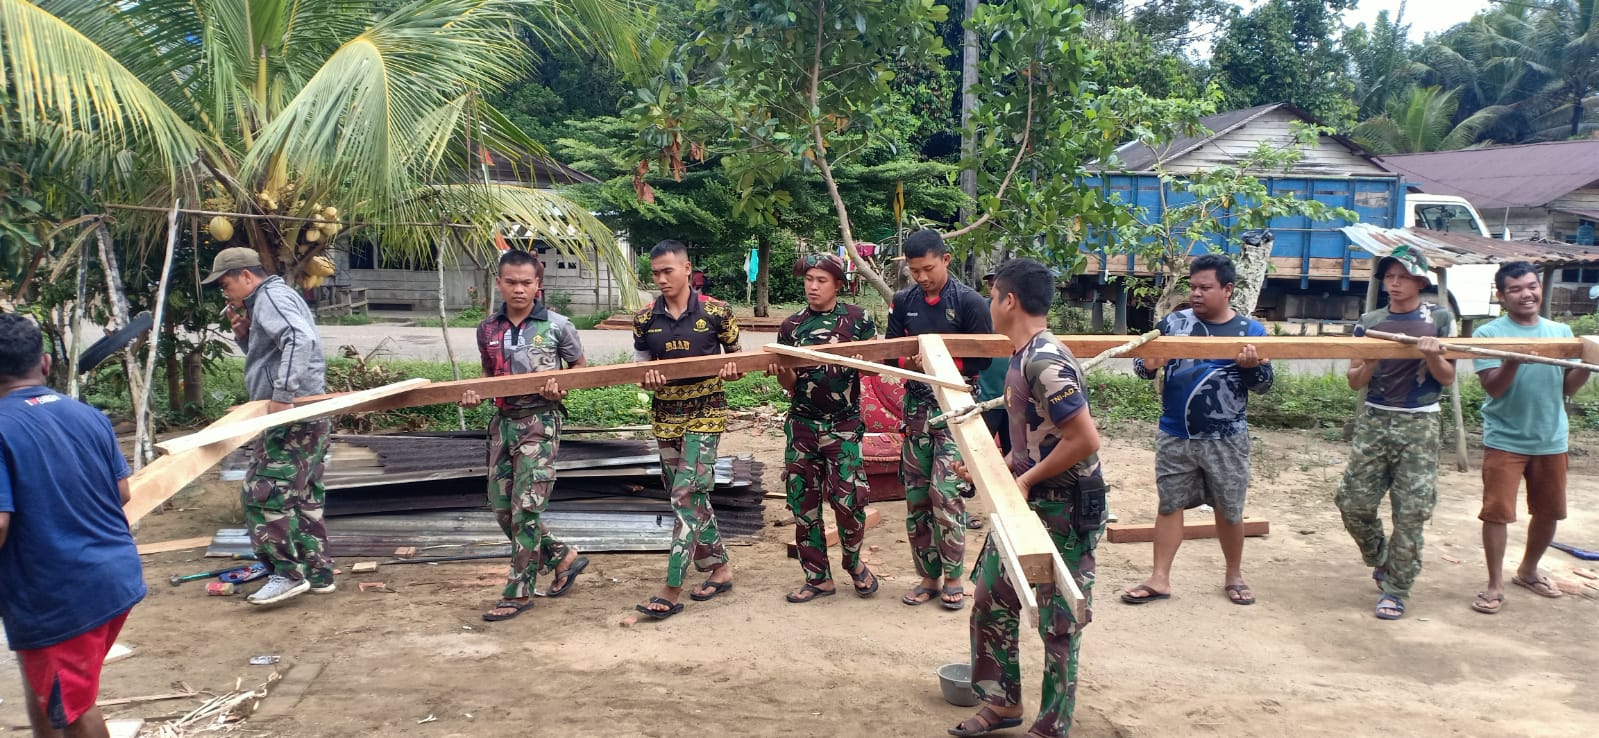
[[205, 248, 334, 605]]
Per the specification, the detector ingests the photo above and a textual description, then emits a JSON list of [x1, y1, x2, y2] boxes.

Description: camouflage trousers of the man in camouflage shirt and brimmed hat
[[784, 414, 867, 585]]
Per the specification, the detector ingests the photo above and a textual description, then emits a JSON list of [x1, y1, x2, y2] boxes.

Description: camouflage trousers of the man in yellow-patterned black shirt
[[656, 431, 728, 586]]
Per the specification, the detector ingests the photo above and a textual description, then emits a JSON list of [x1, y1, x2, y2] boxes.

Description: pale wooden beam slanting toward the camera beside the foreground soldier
[[918, 334, 1087, 621]]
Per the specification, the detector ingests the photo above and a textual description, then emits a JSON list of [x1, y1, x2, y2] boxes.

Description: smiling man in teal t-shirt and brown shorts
[[1471, 262, 1588, 615]]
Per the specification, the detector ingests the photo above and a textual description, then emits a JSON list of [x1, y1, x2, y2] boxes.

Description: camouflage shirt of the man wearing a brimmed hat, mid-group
[[777, 302, 878, 420]]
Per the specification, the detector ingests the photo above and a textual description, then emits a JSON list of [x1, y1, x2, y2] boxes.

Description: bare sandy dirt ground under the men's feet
[[0, 427, 1599, 736]]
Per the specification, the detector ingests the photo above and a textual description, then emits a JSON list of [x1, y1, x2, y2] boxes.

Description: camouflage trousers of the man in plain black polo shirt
[[900, 395, 966, 578]]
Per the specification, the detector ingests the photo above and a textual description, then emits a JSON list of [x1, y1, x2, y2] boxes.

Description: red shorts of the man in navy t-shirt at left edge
[[16, 610, 130, 730]]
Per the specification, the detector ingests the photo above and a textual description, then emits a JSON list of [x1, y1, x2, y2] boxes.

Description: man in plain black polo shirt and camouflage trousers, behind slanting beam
[[887, 230, 993, 610]]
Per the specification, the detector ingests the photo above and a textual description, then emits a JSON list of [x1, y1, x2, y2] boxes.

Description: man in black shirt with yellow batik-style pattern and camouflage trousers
[[633, 241, 739, 620]]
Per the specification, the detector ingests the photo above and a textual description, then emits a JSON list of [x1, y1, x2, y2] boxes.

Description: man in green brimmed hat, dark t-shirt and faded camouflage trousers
[[1335, 246, 1455, 620]]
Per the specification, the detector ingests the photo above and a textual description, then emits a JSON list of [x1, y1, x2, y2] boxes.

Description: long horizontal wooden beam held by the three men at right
[[1059, 335, 1586, 361]]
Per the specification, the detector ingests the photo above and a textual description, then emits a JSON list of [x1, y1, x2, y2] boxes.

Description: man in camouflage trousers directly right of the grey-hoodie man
[[461, 249, 588, 621]]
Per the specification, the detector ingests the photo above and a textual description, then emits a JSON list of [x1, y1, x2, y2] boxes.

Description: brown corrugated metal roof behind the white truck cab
[[1377, 141, 1599, 209]]
